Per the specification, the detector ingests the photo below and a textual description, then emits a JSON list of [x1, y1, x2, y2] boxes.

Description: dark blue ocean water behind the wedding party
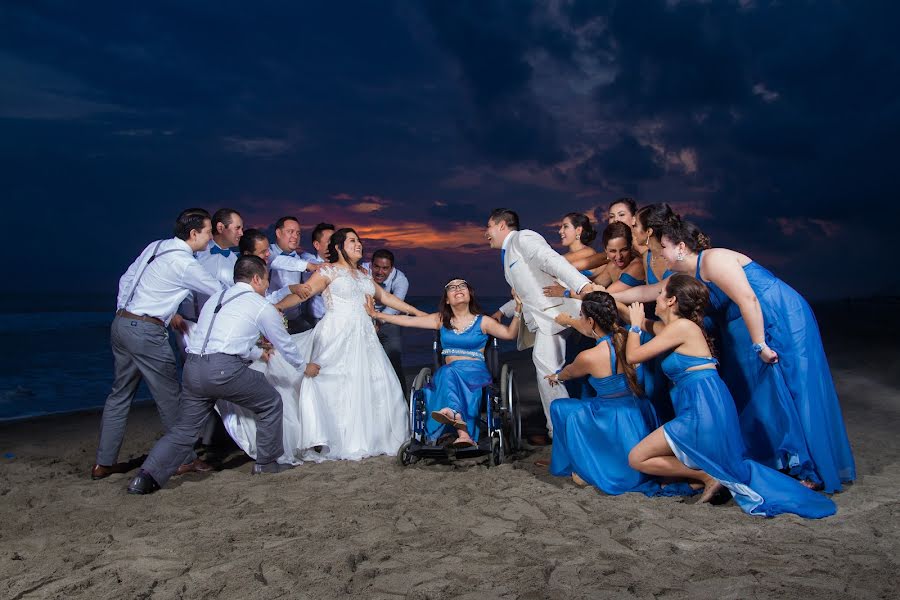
[[0, 295, 515, 421]]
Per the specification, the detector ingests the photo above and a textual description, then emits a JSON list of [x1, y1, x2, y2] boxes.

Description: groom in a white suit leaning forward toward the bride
[[485, 208, 591, 444]]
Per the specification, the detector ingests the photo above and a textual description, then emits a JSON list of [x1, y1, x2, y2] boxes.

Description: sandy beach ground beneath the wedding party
[[0, 344, 900, 600]]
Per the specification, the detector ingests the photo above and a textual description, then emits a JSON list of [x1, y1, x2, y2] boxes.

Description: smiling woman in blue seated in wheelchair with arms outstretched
[[368, 279, 522, 448]]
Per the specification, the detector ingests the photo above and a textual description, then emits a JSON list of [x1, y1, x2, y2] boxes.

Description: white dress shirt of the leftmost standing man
[[116, 238, 224, 325]]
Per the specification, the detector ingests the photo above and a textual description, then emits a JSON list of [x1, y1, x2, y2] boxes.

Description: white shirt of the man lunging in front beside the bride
[[187, 281, 306, 369]]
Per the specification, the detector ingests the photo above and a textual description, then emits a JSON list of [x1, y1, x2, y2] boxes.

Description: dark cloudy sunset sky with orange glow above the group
[[0, 0, 900, 304]]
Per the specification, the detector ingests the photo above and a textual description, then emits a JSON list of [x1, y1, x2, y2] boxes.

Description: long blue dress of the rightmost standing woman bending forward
[[696, 252, 856, 492]]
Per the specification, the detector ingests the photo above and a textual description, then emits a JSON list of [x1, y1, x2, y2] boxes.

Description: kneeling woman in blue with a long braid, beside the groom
[[547, 292, 692, 496]]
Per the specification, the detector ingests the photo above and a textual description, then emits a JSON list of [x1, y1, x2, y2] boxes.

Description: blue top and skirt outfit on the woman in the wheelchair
[[422, 315, 491, 441]]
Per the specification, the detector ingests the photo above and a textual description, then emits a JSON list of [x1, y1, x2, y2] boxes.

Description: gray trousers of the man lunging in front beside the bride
[[141, 354, 284, 486]]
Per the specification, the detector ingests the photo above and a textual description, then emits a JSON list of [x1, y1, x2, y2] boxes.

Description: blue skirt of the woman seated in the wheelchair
[[422, 360, 491, 441]]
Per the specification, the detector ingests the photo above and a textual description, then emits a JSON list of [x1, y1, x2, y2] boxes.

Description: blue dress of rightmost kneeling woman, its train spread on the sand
[[662, 352, 837, 519]]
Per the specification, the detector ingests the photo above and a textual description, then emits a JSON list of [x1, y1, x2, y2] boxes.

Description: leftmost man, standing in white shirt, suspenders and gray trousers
[[91, 208, 223, 479]]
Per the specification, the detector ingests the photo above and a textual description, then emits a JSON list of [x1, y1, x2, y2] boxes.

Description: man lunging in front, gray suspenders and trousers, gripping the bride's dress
[[128, 255, 319, 494]]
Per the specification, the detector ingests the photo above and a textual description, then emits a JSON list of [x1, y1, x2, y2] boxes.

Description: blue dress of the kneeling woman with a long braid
[[550, 336, 694, 496]]
